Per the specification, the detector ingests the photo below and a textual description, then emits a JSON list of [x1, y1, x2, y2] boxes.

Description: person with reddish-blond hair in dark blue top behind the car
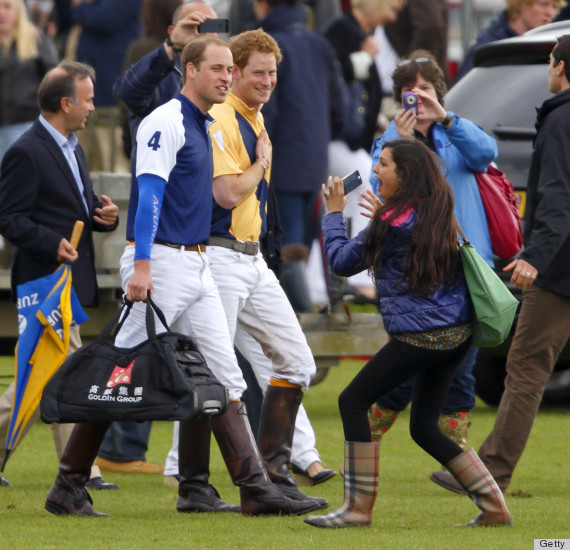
[[457, 0, 566, 80]]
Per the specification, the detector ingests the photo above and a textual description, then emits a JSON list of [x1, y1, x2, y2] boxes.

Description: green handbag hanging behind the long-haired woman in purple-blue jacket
[[459, 227, 519, 348]]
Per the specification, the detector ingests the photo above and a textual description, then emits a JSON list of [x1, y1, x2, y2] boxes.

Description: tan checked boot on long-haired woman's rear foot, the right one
[[447, 449, 513, 527]]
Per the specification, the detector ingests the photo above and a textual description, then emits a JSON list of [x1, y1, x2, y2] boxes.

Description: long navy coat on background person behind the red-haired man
[[260, 5, 347, 193]]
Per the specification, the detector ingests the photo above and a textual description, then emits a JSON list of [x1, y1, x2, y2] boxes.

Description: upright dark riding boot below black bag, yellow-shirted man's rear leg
[[176, 418, 241, 512]]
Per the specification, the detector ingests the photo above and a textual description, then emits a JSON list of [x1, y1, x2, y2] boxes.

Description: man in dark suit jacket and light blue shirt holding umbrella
[[0, 61, 119, 488]]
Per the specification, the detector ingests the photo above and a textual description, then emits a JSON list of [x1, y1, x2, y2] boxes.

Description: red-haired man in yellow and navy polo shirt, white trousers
[[208, 30, 334, 508]]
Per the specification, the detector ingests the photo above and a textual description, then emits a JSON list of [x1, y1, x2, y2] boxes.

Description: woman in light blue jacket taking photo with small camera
[[369, 50, 498, 470]]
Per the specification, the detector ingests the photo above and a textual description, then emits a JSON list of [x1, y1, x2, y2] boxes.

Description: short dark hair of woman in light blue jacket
[[392, 50, 447, 106]]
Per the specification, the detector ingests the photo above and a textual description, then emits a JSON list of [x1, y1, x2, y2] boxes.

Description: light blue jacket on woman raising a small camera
[[370, 116, 498, 267]]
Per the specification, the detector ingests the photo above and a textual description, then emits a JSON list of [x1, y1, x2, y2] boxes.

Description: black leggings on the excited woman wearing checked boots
[[338, 338, 471, 464]]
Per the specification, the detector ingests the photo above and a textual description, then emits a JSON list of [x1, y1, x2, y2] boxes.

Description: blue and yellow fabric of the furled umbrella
[[6, 265, 88, 450]]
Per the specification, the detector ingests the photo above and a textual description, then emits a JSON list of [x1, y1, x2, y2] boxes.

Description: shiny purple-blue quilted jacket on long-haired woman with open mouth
[[322, 212, 471, 334]]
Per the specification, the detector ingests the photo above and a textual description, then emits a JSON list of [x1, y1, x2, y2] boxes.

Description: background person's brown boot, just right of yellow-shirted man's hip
[[279, 243, 313, 313]]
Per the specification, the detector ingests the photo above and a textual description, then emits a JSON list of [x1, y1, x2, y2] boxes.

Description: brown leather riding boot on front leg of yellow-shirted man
[[257, 380, 329, 508]]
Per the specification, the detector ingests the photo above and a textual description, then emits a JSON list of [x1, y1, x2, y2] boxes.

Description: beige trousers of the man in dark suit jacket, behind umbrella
[[0, 326, 101, 477]]
